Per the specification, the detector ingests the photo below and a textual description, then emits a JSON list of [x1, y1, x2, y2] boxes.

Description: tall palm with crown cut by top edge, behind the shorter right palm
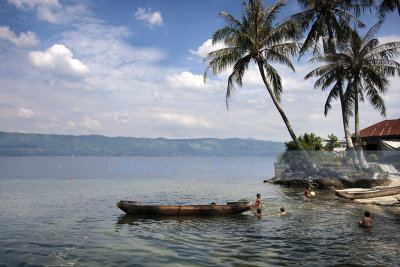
[[288, 0, 373, 169]]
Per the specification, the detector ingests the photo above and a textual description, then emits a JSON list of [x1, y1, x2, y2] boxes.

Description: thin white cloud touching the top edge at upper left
[[8, 0, 86, 24]]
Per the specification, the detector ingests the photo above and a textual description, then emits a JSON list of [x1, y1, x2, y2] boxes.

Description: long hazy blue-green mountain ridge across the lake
[[0, 132, 284, 157]]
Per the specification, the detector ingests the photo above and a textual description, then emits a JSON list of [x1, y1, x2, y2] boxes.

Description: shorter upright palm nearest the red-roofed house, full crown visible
[[306, 22, 400, 169]]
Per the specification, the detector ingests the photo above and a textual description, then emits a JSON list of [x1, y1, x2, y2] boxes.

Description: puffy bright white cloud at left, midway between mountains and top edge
[[29, 44, 90, 79]]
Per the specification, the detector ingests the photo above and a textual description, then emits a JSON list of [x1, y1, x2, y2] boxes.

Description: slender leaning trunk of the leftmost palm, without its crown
[[257, 61, 319, 172]]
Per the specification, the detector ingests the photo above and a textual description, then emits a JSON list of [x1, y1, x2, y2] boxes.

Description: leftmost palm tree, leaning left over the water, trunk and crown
[[204, 0, 318, 171]]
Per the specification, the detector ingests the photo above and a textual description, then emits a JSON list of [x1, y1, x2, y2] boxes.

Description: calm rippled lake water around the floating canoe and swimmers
[[0, 157, 400, 266]]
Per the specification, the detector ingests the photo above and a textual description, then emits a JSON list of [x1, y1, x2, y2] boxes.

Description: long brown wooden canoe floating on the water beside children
[[117, 200, 252, 216]]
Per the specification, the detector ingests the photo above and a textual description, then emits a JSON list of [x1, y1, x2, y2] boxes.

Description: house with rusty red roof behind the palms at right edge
[[351, 119, 400, 160]]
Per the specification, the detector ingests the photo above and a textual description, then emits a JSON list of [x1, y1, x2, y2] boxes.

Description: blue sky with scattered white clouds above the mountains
[[0, 0, 400, 141]]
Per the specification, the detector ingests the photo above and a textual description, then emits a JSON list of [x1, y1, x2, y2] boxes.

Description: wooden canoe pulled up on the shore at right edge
[[335, 186, 400, 199]]
